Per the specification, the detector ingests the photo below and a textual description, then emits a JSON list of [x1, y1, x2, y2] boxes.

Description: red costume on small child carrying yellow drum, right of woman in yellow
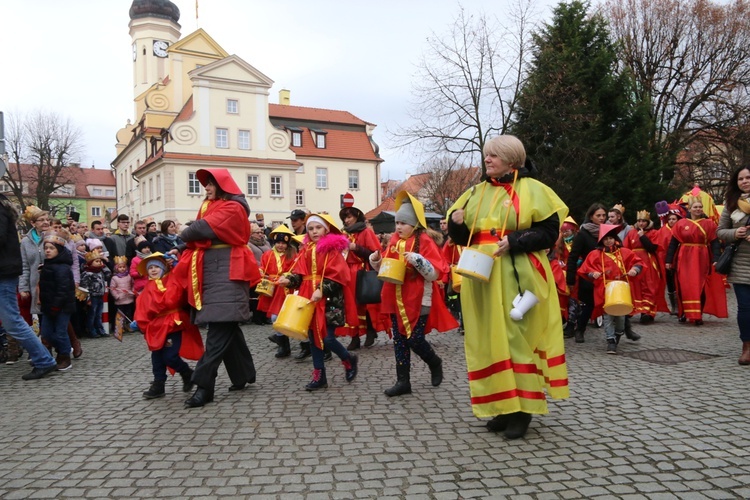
[[578, 248, 643, 318]]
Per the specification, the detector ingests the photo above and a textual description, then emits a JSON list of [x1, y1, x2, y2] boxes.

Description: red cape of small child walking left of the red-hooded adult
[[134, 274, 203, 360]]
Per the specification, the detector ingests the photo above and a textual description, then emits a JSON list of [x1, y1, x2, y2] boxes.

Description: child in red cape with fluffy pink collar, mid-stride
[[279, 214, 357, 391]]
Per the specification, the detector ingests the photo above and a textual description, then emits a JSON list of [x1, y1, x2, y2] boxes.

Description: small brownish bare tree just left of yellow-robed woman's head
[[419, 155, 482, 214]]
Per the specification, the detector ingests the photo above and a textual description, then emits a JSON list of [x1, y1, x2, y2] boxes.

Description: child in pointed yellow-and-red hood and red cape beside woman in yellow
[[370, 191, 458, 397]]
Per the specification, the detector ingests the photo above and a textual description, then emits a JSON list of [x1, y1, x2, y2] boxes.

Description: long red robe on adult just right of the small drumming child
[[623, 228, 669, 316]]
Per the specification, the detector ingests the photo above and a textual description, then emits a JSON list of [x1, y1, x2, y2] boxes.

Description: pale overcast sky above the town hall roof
[[0, 0, 555, 179]]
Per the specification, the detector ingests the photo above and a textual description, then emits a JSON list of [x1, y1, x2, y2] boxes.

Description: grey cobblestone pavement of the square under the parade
[[0, 293, 750, 499]]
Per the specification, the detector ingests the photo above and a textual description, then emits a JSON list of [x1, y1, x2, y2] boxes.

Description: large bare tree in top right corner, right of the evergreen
[[603, 0, 750, 185]]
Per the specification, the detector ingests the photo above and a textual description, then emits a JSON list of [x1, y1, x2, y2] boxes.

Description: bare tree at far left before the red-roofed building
[[2, 111, 82, 210]]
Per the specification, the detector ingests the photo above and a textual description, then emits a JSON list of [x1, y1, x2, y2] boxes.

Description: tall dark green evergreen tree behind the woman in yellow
[[511, 0, 665, 223]]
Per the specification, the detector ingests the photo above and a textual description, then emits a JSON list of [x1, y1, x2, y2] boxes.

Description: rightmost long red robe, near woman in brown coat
[[672, 219, 728, 321]]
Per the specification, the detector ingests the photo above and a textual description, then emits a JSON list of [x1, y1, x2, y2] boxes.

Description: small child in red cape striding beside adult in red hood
[[131, 252, 203, 399]]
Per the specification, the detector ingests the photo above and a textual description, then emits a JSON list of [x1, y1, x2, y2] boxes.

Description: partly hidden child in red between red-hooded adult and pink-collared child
[[258, 224, 297, 358]]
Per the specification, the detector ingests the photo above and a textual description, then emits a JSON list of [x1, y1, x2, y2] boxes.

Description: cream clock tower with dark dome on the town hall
[[129, 0, 180, 98]]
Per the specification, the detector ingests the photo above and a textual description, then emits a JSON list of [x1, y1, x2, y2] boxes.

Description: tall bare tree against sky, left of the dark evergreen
[[391, 0, 536, 178]]
